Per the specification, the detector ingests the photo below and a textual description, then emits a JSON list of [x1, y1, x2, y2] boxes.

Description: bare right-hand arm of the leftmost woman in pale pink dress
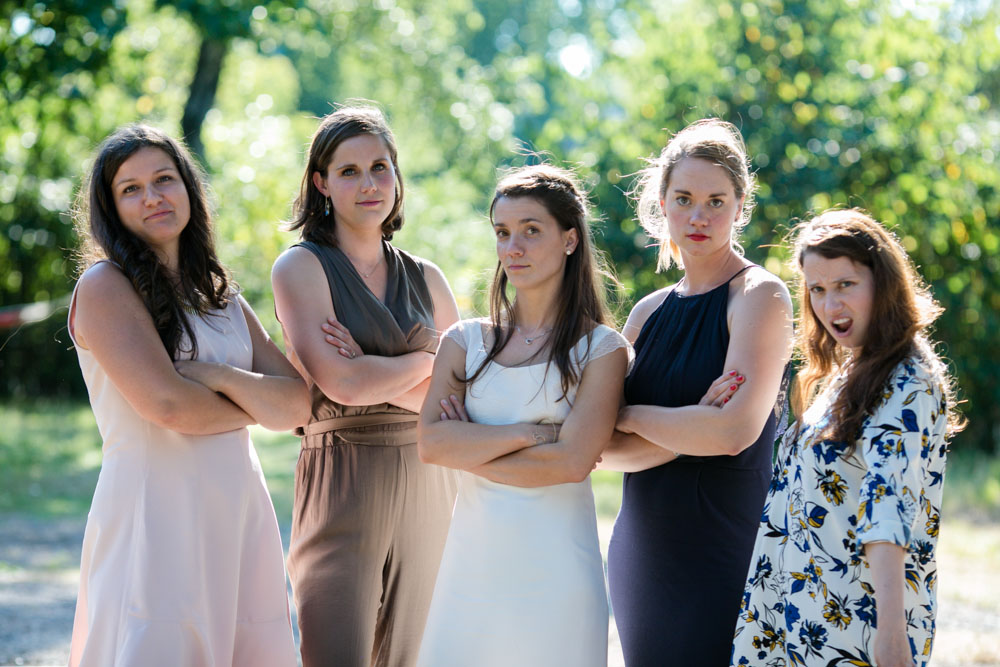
[[174, 296, 309, 431]]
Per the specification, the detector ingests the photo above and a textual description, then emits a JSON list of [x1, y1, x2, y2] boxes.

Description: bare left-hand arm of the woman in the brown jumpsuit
[[271, 248, 434, 405]]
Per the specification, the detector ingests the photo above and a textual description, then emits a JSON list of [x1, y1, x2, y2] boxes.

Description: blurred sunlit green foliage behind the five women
[[0, 0, 1000, 451]]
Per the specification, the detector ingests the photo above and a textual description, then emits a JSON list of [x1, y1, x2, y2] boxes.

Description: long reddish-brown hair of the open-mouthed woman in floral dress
[[792, 209, 964, 448]]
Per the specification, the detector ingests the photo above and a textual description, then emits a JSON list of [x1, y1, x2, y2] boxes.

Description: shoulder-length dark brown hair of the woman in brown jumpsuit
[[287, 105, 403, 246]]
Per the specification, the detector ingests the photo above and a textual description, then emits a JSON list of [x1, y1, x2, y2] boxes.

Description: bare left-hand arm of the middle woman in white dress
[[417, 338, 552, 470]]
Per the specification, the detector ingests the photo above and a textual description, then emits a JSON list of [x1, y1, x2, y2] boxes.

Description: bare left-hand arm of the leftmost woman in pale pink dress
[[71, 262, 254, 435]]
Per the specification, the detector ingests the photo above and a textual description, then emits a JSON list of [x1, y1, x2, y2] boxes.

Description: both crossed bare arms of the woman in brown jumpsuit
[[271, 248, 458, 412]]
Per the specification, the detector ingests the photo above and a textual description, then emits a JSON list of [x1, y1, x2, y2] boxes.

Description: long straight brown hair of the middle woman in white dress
[[466, 164, 620, 398]]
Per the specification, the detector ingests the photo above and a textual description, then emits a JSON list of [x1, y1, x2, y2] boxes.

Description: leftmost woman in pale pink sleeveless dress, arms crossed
[[69, 125, 309, 667]]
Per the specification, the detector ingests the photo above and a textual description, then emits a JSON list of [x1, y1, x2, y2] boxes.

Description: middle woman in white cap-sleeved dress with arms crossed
[[417, 165, 629, 667]]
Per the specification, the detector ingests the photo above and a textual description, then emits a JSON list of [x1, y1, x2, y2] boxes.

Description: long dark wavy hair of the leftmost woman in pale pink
[[74, 125, 230, 359]]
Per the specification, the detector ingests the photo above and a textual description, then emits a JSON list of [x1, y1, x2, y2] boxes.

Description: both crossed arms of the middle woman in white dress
[[417, 338, 628, 487]]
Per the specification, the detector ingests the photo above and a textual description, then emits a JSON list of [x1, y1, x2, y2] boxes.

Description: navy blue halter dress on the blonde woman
[[608, 268, 775, 667]]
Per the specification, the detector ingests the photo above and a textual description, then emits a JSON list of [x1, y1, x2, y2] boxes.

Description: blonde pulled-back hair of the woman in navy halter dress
[[630, 118, 757, 271]]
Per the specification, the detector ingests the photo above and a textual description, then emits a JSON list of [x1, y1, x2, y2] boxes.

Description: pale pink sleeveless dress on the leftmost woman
[[70, 295, 296, 667]]
